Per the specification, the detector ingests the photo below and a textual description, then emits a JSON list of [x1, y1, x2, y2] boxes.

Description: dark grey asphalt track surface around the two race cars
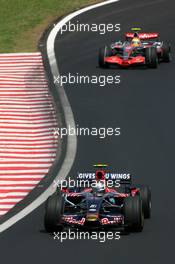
[[0, 0, 175, 264]]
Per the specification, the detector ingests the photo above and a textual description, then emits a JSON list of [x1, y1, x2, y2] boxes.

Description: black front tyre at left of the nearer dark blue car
[[44, 193, 63, 233]]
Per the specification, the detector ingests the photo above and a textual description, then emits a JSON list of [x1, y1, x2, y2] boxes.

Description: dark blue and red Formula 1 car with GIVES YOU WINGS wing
[[44, 164, 151, 232]]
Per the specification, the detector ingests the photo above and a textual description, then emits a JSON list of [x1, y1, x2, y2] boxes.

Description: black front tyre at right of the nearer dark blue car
[[123, 196, 144, 232]]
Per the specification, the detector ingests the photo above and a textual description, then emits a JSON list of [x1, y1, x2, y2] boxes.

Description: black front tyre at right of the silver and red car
[[145, 47, 158, 68]]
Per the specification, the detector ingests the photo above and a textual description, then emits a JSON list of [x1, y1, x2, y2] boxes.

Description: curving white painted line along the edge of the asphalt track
[[0, 0, 119, 232]]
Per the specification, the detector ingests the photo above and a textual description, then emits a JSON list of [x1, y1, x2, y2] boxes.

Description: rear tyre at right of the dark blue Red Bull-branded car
[[139, 186, 151, 218]]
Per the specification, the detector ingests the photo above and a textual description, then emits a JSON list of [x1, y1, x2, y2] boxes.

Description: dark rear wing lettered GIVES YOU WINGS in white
[[77, 172, 132, 184]]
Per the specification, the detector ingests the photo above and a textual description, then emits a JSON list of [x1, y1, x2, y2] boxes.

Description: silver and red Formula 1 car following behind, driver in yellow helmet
[[99, 28, 171, 68]]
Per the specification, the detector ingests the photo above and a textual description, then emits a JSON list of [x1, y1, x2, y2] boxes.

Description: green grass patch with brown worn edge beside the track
[[0, 0, 100, 53]]
